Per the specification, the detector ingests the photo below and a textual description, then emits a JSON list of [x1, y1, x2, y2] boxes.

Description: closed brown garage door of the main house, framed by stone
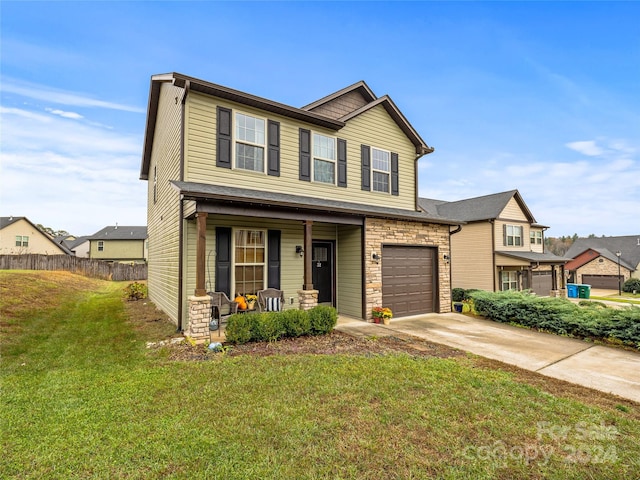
[[382, 245, 436, 317]]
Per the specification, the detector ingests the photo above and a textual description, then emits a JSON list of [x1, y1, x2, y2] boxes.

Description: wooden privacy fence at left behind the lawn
[[0, 254, 147, 281]]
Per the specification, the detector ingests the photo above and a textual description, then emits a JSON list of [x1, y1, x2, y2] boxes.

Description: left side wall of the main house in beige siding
[[147, 83, 182, 324]]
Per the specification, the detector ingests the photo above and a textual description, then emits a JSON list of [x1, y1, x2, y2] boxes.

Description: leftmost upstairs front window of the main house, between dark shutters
[[235, 113, 265, 173]]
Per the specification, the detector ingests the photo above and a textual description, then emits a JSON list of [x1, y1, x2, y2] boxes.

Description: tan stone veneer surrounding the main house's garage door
[[364, 218, 451, 320]]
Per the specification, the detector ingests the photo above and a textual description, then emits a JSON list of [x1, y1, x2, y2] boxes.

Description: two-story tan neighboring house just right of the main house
[[419, 190, 567, 296]]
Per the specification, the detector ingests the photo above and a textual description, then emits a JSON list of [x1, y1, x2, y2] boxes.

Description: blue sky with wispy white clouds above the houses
[[0, 1, 640, 236]]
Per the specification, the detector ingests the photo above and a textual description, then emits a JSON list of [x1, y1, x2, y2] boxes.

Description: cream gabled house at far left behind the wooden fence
[[0, 217, 71, 255]]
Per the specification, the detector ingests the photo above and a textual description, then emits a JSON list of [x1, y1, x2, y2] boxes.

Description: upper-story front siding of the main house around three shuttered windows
[[185, 92, 415, 210]]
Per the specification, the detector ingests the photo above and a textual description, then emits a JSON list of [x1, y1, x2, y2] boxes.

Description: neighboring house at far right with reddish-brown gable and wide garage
[[565, 235, 640, 290]]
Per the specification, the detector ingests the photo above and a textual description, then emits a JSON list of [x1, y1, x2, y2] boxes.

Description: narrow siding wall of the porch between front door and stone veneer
[[336, 225, 363, 318]]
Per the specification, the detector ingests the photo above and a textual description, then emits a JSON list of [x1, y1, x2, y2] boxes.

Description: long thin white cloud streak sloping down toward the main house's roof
[[2, 77, 145, 113]]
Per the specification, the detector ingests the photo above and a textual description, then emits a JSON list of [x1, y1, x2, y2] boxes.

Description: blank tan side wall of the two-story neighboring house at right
[[451, 222, 493, 291]]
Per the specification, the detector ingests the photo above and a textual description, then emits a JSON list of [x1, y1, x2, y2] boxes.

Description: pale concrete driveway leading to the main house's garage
[[336, 313, 640, 402]]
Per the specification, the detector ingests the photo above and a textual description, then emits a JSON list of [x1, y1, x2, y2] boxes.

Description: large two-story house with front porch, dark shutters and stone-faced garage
[[140, 73, 457, 338]]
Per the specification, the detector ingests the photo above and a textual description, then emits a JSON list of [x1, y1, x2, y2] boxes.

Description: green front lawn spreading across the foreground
[[0, 272, 640, 479]]
